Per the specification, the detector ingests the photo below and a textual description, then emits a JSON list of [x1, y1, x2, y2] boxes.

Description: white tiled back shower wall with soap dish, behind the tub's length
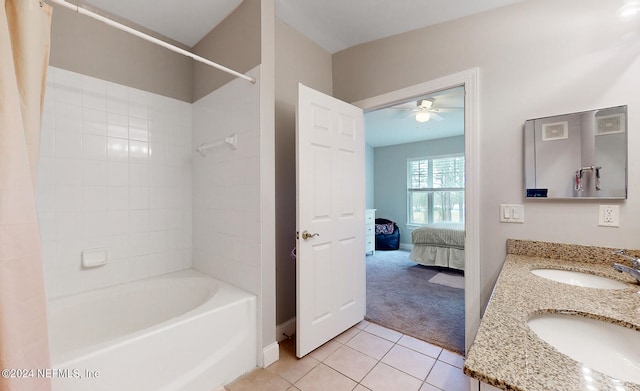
[[36, 67, 193, 298]]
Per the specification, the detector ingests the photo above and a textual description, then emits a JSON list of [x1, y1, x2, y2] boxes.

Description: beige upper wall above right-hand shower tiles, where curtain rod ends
[[193, 0, 261, 102]]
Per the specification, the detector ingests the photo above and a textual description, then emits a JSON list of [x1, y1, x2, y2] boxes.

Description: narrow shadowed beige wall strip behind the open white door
[[275, 19, 332, 324]]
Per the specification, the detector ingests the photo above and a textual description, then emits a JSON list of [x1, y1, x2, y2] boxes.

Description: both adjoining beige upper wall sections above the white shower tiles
[[49, 0, 261, 102]]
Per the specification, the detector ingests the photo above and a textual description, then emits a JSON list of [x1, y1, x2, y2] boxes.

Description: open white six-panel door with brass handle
[[296, 84, 366, 357]]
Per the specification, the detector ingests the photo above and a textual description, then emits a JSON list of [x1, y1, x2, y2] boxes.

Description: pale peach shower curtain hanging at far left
[[0, 0, 51, 391]]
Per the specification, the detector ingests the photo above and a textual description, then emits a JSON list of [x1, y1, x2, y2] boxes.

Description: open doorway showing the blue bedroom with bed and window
[[364, 86, 465, 354]]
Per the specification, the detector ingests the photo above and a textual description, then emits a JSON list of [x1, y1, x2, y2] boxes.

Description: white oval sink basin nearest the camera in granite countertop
[[527, 314, 640, 384]]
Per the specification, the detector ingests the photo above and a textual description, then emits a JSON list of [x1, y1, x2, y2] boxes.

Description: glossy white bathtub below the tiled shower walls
[[48, 270, 257, 391]]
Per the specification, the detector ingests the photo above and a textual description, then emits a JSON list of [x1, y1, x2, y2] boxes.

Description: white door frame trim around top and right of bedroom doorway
[[352, 68, 481, 353]]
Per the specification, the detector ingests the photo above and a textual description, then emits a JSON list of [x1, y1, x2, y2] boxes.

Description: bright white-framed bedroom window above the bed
[[407, 155, 464, 225]]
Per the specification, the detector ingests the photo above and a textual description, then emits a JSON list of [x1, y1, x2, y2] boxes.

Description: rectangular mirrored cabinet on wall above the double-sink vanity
[[524, 106, 627, 199]]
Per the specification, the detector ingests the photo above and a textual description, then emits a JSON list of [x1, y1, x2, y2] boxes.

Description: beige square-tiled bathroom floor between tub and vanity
[[226, 321, 469, 391]]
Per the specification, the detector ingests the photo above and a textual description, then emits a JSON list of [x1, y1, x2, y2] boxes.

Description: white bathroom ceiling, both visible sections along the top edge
[[81, 0, 523, 53]]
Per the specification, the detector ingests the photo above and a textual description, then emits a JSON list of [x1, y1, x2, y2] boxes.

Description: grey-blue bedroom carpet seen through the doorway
[[365, 251, 464, 354]]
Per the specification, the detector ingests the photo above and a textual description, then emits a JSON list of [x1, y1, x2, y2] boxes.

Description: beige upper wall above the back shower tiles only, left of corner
[[49, 6, 193, 102]]
